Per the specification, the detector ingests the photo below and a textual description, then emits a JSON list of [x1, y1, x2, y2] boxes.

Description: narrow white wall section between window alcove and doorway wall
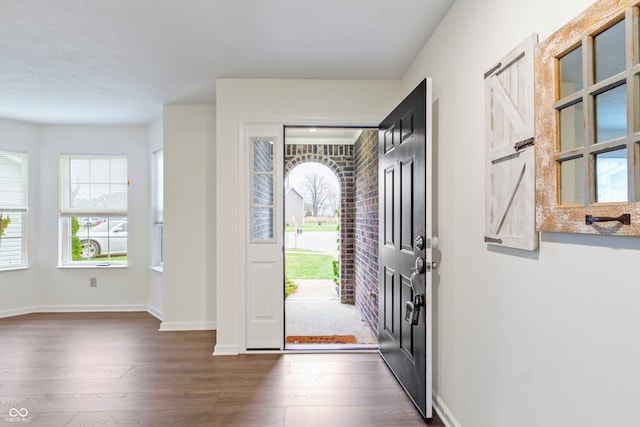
[[160, 105, 216, 330]]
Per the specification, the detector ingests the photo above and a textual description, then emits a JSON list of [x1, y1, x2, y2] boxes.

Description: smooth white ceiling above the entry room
[[0, 0, 453, 124]]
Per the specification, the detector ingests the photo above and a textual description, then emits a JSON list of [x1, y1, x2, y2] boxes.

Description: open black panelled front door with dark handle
[[378, 80, 432, 418]]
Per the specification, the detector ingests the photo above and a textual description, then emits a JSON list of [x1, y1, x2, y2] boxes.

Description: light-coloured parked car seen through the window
[[76, 219, 127, 259]]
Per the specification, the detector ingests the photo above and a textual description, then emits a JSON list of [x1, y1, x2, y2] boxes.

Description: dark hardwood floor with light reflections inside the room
[[0, 313, 443, 427]]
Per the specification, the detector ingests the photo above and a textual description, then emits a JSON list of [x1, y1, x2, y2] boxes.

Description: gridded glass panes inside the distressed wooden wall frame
[[554, 10, 640, 205]]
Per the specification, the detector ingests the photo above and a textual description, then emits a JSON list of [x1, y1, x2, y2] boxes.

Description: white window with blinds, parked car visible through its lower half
[[59, 154, 129, 267]]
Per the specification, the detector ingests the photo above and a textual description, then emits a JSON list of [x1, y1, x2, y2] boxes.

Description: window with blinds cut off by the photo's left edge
[[0, 151, 29, 271]]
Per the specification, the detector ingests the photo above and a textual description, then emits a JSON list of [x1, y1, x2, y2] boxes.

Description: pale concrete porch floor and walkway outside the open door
[[285, 280, 378, 348]]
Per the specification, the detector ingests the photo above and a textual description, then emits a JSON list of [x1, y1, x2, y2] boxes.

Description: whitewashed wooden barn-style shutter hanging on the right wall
[[484, 34, 538, 250]]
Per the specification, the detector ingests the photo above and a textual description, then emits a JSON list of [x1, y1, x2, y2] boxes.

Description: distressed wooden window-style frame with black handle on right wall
[[535, 0, 640, 236]]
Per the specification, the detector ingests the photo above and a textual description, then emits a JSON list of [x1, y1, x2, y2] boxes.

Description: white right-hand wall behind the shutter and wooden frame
[[403, 0, 640, 427]]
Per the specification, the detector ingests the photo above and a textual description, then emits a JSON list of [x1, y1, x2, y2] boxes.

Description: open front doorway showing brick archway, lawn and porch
[[284, 126, 378, 350]]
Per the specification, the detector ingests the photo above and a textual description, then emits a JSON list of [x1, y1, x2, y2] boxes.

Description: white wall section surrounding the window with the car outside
[[35, 126, 150, 311]]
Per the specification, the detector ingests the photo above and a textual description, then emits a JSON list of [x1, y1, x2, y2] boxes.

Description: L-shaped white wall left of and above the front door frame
[[215, 79, 400, 354]]
